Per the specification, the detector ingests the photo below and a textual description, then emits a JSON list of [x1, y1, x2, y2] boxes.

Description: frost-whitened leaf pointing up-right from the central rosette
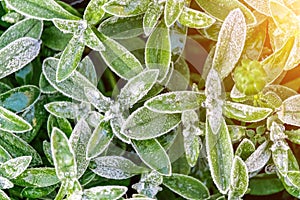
[[118, 70, 158, 107]]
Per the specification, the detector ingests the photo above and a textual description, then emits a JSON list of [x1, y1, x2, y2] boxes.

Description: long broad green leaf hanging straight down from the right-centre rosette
[[205, 119, 233, 194]]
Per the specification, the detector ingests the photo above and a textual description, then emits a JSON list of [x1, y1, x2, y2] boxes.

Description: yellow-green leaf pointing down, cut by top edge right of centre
[[164, 0, 185, 27]]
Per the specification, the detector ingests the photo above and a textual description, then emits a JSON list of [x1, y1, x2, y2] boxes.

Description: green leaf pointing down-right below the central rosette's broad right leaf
[[132, 139, 171, 176]]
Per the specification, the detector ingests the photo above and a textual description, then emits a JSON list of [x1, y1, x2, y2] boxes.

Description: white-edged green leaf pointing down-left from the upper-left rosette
[[56, 36, 84, 82]]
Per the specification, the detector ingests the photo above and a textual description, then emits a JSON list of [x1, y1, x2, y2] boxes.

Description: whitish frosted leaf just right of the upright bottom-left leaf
[[69, 119, 92, 178]]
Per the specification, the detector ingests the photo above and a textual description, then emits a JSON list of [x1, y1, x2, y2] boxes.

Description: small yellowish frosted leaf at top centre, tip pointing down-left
[[143, 3, 164, 36]]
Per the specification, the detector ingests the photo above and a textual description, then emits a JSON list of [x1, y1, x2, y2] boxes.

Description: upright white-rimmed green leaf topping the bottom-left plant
[[51, 127, 77, 180]]
